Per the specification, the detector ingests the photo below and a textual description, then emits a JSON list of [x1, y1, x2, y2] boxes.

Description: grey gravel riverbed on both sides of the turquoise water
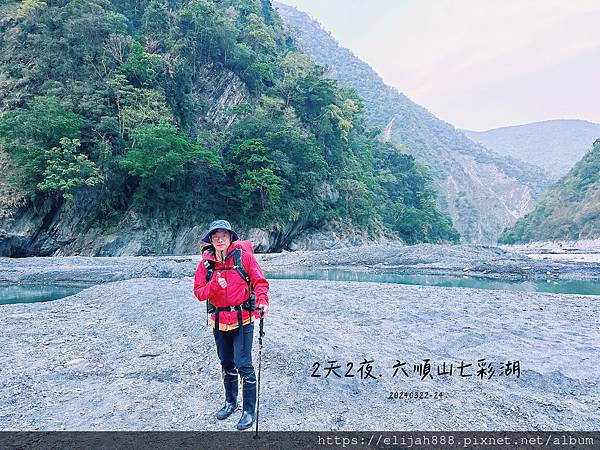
[[0, 246, 600, 430]]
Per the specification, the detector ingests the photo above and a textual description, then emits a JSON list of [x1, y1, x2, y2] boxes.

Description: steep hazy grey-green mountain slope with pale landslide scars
[[274, 3, 549, 243]]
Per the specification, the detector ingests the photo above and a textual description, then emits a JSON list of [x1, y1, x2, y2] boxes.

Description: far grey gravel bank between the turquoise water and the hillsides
[[0, 244, 600, 283]]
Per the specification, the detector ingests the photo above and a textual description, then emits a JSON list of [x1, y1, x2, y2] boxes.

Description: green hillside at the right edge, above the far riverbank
[[498, 139, 600, 244]]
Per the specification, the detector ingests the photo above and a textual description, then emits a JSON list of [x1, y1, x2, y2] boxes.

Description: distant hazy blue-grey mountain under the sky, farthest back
[[462, 120, 600, 179]]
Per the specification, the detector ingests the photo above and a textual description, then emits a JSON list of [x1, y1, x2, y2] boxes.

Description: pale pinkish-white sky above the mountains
[[279, 0, 600, 131]]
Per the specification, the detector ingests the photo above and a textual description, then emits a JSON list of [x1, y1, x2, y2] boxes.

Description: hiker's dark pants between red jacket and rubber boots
[[213, 323, 256, 383]]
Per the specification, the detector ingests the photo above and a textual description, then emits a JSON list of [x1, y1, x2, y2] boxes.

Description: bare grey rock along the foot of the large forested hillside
[[0, 195, 380, 257]]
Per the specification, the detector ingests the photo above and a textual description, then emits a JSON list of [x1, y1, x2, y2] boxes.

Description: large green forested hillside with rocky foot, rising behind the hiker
[[0, 0, 458, 255]]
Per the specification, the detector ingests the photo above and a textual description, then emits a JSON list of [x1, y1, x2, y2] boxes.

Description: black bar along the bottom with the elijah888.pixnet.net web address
[[0, 431, 600, 450]]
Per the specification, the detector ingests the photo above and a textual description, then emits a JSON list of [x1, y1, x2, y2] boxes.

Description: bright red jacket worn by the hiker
[[194, 240, 269, 331]]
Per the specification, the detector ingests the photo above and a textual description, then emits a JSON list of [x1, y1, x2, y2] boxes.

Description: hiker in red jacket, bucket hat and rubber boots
[[194, 220, 269, 430]]
